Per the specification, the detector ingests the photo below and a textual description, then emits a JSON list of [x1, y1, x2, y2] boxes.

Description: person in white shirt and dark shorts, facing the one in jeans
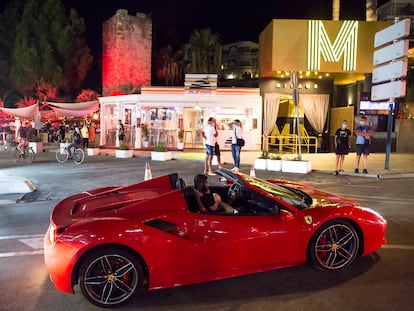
[[203, 117, 221, 175]]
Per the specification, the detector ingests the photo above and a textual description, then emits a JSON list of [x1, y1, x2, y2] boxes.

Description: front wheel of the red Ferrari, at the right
[[309, 220, 359, 271]]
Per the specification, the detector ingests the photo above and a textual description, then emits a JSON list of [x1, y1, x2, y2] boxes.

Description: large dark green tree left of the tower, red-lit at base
[[0, 0, 92, 100]]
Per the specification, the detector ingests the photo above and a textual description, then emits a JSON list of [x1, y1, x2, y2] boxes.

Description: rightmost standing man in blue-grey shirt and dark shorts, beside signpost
[[354, 116, 373, 174]]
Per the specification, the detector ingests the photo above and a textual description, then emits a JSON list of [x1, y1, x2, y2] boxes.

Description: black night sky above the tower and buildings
[[63, 0, 365, 51]]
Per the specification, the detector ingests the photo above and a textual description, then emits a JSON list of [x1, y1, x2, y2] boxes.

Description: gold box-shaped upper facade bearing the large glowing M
[[259, 19, 391, 80]]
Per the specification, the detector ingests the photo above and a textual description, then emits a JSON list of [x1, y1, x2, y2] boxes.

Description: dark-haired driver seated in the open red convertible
[[194, 174, 234, 214]]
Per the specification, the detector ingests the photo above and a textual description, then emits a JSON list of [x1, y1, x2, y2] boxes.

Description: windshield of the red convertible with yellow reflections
[[246, 176, 312, 209]]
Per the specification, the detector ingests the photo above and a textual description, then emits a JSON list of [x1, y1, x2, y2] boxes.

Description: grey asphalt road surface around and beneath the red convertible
[[0, 153, 414, 311]]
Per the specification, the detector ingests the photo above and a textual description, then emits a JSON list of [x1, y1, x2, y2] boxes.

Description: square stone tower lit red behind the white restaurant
[[102, 9, 152, 96]]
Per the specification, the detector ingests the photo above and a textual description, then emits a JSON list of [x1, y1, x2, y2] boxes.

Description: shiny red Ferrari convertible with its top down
[[44, 169, 387, 307]]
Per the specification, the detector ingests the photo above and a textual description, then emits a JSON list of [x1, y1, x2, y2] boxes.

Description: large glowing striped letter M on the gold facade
[[308, 20, 358, 71]]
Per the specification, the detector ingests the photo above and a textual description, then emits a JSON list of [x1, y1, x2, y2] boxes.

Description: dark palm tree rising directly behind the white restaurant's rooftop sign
[[184, 28, 221, 73]]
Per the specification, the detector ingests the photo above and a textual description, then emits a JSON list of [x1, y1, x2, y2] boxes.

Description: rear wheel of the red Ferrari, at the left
[[79, 248, 144, 308]]
